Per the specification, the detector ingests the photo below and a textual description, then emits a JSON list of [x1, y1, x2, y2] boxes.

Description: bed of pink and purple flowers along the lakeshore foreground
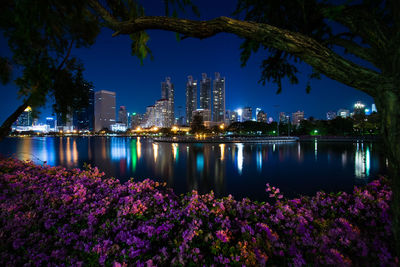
[[0, 159, 397, 266]]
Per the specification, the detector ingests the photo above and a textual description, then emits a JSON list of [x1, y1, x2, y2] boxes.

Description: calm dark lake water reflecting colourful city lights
[[0, 137, 386, 200]]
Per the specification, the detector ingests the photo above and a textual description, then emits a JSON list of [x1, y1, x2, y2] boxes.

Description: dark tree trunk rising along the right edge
[[375, 87, 400, 256]]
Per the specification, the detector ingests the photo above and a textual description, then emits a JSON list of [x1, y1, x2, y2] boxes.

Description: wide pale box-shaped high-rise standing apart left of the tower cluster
[[94, 90, 116, 132]]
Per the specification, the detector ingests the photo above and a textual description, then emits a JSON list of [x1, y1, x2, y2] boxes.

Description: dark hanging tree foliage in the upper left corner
[[0, 0, 100, 116]]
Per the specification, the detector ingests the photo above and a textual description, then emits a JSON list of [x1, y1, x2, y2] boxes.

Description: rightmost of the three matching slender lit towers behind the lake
[[212, 72, 225, 123]]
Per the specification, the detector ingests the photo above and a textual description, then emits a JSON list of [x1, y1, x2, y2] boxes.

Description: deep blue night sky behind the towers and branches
[[0, 0, 373, 122]]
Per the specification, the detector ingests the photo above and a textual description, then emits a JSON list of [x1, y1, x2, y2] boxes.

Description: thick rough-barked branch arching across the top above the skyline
[[90, 0, 381, 96]]
